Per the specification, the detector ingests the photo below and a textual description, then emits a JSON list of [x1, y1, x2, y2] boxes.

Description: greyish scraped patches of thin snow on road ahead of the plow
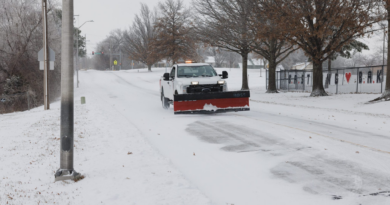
[[186, 120, 390, 196]]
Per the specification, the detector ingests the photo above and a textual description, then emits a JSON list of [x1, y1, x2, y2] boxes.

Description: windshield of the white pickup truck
[[177, 65, 217, 78]]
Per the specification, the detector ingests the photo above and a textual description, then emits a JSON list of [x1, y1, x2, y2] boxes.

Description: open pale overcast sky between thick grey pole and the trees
[[74, 0, 191, 55]]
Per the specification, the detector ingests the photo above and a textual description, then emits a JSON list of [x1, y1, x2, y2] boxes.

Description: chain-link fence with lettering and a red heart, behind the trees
[[266, 66, 387, 94]]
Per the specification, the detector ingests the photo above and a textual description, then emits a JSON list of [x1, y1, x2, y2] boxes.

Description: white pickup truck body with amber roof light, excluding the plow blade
[[160, 63, 228, 109]]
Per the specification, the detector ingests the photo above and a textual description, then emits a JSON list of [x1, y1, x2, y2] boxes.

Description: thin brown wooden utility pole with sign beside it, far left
[[42, 0, 50, 110]]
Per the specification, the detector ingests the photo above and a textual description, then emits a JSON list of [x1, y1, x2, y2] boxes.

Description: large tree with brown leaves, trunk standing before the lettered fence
[[259, 0, 378, 96]]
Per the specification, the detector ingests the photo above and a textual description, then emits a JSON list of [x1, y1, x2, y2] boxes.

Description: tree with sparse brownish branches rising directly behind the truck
[[154, 0, 199, 63]]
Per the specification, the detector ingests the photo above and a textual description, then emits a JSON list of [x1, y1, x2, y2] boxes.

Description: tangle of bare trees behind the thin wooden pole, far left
[[0, 0, 61, 112]]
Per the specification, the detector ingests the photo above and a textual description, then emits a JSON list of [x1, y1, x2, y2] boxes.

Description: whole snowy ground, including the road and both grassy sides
[[0, 69, 390, 205]]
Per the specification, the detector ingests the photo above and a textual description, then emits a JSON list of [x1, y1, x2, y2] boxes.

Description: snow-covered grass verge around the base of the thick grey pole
[[0, 95, 209, 205]]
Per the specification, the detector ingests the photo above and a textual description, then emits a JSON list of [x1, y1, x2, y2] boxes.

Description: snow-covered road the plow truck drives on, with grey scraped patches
[[82, 70, 390, 204]]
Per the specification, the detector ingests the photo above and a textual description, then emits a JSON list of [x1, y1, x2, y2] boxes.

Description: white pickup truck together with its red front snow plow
[[160, 63, 250, 114]]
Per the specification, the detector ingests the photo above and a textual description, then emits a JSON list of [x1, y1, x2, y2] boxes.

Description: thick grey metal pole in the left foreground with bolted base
[[54, 0, 80, 181]]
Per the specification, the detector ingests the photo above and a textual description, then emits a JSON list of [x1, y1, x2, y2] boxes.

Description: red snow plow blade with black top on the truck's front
[[173, 91, 250, 114]]
